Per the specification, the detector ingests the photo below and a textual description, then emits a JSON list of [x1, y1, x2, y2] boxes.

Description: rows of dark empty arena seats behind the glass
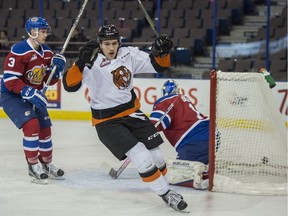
[[0, 0, 287, 80]]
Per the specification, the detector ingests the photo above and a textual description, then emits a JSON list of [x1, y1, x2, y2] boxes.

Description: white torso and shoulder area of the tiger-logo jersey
[[82, 47, 157, 110]]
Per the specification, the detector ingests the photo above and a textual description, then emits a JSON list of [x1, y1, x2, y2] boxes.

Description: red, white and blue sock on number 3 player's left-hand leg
[[22, 118, 40, 164]]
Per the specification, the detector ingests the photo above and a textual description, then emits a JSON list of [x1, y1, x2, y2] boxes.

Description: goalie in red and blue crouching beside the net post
[[150, 80, 209, 189]]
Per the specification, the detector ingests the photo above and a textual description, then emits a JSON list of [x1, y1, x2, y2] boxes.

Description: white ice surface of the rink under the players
[[0, 119, 287, 216]]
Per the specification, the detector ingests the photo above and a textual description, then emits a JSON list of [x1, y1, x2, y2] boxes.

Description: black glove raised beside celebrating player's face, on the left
[[75, 40, 100, 71]]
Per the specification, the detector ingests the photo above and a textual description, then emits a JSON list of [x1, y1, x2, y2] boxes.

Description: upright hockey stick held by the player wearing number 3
[[43, 0, 88, 93]]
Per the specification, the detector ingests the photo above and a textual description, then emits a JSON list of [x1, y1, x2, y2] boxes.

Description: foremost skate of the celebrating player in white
[[161, 190, 190, 213]]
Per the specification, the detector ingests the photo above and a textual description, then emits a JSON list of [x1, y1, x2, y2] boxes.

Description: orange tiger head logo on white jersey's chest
[[111, 66, 131, 90]]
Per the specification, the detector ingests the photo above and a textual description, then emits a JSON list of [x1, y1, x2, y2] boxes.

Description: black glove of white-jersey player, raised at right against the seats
[[151, 34, 173, 57]]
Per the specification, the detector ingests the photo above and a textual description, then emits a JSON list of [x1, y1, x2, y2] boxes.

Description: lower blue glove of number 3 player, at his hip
[[20, 86, 48, 109]]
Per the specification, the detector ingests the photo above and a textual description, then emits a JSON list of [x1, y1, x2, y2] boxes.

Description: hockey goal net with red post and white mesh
[[209, 71, 287, 195]]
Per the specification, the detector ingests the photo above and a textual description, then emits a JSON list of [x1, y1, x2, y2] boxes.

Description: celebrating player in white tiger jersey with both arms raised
[[63, 25, 187, 211]]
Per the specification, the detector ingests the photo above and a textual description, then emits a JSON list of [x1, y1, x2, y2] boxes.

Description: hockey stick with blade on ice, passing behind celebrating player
[[101, 97, 179, 179]]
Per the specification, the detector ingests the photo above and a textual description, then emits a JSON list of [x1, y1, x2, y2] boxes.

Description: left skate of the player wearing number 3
[[28, 162, 48, 184]]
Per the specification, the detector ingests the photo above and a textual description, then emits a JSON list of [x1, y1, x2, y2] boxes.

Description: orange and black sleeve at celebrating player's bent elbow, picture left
[[62, 64, 83, 92]]
